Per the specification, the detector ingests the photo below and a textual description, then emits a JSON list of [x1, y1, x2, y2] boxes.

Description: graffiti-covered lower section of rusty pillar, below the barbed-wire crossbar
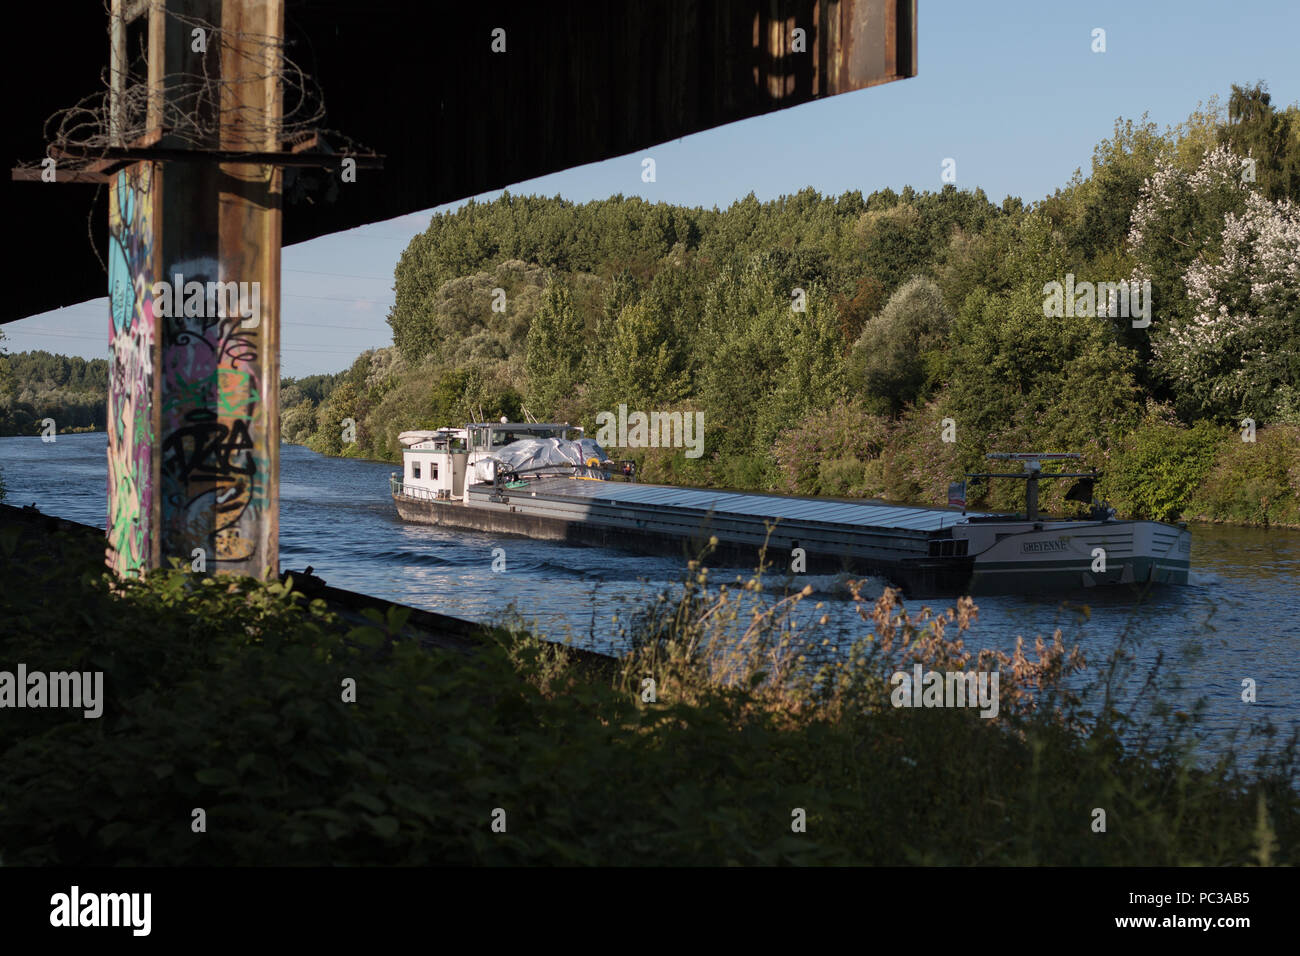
[[108, 164, 280, 576]]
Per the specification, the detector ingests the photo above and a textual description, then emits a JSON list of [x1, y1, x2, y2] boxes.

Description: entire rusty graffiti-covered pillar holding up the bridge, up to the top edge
[[108, 0, 285, 578]]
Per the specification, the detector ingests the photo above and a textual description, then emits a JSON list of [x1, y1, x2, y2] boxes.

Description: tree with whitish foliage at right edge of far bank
[[1128, 147, 1300, 420]]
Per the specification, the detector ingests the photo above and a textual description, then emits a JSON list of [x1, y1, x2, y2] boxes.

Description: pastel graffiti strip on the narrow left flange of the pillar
[[108, 163, 155, 575]]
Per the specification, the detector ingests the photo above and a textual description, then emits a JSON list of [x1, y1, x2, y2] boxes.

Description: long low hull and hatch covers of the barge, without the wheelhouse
[[393, 477, 1191, 597]]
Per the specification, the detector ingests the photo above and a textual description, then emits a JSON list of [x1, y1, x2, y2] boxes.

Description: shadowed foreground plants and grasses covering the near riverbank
[[0, 509, 1300, 866]]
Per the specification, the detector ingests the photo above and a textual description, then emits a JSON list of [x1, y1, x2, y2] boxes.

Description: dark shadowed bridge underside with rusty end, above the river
[[0, 0, 917, 323]]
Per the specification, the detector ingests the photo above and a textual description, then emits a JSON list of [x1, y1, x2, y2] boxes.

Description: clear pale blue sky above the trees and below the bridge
[[3, 0, 1300, 376]]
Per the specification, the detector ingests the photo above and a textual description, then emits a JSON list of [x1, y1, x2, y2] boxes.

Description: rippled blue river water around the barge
[[0, 433, 1300, 750]]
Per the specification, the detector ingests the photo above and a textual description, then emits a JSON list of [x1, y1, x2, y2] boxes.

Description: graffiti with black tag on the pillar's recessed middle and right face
[[161, 273, 269, 564]]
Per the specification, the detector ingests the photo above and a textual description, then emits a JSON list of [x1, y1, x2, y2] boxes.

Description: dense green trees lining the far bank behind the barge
[[282, 86, 1300, 524]]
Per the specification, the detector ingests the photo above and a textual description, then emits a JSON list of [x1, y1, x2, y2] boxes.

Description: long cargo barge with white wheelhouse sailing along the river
[[390, 421, 1191, 596]]
